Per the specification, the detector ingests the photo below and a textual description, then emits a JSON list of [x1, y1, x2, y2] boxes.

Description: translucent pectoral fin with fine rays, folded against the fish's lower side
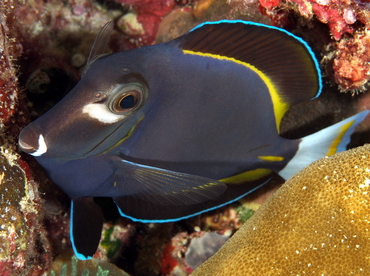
[[113, 160, 226, 206]]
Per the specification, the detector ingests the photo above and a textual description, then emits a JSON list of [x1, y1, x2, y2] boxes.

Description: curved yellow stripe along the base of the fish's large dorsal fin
[[183, 50, 289, 133]]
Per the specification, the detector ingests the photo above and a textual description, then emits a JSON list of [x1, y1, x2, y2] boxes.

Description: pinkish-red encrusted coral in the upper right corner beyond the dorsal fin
[[259, 0, 370, 93]]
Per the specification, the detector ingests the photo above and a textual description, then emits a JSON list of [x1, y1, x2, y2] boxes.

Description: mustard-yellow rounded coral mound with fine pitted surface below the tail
[[192, 145, 370, 276]]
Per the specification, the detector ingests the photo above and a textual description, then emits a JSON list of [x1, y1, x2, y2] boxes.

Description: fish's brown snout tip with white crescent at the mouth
[[18, 124, 47, 156]]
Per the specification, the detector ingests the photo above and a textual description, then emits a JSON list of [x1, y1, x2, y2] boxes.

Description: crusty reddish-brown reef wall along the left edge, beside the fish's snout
[[0, 1, 55, 276]]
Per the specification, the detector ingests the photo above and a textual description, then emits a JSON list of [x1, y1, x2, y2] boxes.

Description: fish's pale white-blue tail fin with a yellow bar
[[279, 110, 370, 179]]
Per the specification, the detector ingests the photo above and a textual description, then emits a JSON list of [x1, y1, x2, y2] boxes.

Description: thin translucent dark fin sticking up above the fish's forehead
[[83, 21, 114, 74]]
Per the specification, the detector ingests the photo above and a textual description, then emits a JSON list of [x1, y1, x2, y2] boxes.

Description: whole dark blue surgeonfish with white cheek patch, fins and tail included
[[19, 21, 368, 259]]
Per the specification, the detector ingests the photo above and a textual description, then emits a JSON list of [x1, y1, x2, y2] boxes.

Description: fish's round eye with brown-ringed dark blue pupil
[[108, 83, 147, 114]]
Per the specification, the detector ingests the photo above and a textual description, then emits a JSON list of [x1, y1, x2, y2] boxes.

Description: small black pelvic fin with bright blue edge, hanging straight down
[[70, 197, 104, 260]]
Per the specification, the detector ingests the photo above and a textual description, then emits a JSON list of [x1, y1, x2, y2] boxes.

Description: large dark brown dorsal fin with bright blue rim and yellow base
[[170, 20, 322, 131]]
